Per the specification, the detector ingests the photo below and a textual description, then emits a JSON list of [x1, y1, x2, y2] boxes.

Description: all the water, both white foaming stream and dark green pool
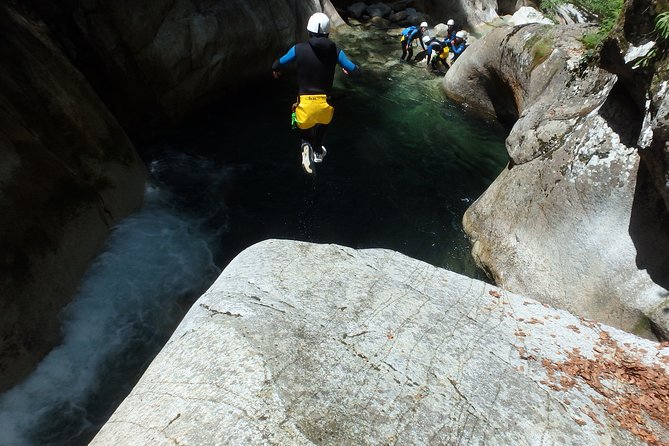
[[0, 23, 507, 446]]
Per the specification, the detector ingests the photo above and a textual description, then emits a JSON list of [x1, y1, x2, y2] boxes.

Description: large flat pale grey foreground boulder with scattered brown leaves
[[91, 240, 669, 446]]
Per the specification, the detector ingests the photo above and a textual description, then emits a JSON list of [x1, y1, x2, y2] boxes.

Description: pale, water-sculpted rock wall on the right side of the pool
[[444, 2, 669, 337]]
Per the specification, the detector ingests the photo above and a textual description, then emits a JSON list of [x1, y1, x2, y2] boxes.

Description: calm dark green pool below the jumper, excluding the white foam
[[154, 25, 507, 278]]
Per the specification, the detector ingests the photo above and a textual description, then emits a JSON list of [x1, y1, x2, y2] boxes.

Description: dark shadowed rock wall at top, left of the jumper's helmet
[[28, 0, 341, 138]]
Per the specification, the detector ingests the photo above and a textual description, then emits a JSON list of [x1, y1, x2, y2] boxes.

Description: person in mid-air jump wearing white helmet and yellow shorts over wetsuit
[[272, 12, 359, 174]]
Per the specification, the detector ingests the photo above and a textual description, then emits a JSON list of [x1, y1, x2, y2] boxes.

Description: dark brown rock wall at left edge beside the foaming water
[[0, 4, 145, 392]]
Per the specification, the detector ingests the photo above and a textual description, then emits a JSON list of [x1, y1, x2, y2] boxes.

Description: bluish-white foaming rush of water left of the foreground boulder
[[0, 183, 218, 446]]
